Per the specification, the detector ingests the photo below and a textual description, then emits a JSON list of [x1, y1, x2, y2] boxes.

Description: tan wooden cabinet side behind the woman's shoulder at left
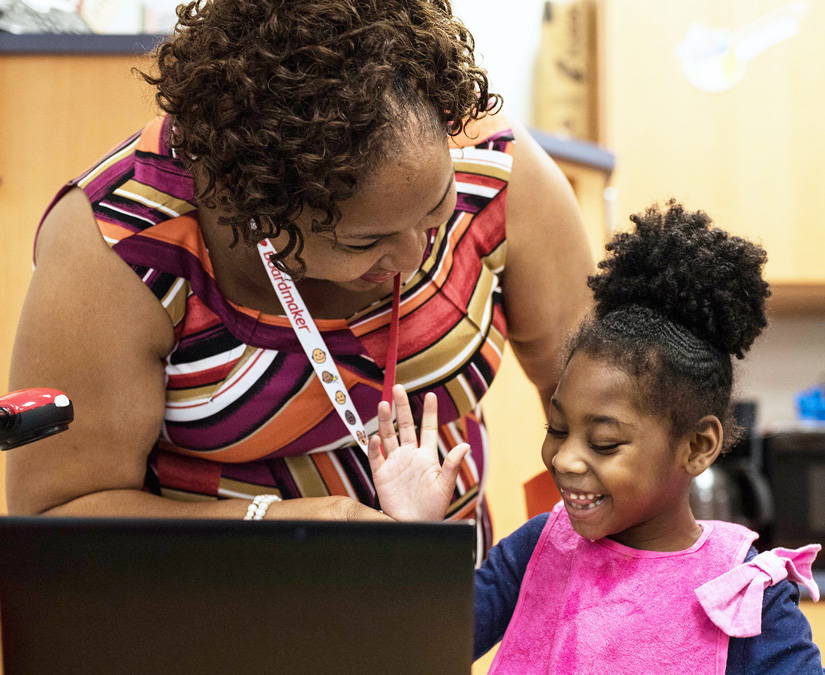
[[0, 54, 156, 387]]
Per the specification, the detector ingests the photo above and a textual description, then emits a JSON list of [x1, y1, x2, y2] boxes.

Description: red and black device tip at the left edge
[[0, 387, 74, 450]]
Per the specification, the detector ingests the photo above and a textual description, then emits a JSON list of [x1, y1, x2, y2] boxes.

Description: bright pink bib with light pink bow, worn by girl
[[490, 503, 819, 675]]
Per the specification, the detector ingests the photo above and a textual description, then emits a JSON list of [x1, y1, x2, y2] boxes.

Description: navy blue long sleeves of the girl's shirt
[[474, 513, 823, 675]]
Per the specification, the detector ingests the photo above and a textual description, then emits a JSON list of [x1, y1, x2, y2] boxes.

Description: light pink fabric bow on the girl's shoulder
[[694, 544, 822, 637]]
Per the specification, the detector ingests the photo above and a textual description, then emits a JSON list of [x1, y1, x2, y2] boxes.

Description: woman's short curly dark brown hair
[[140, 0, 500, 275]]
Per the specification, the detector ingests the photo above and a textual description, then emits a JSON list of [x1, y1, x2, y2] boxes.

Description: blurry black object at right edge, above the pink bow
[[764, 427, 825, 569]]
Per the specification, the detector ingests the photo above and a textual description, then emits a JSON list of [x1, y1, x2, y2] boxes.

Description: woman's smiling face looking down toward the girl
[[273, 138, 456, 292]]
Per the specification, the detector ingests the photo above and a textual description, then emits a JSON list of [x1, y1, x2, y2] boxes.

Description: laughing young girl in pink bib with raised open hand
[[370, 202, 822, 675]]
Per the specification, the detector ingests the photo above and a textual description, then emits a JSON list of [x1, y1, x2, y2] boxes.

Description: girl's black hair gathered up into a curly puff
[[568, 200, 770, 449]]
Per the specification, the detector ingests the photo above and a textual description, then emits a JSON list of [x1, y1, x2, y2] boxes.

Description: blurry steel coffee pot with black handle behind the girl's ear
[[690, 401, 772, 549]]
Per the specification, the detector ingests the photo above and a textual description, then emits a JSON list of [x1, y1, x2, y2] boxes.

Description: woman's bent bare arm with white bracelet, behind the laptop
[[6, 190, 384, 519]]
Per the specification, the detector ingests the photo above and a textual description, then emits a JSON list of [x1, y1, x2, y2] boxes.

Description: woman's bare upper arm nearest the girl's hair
[[503, 124, 593, 413]]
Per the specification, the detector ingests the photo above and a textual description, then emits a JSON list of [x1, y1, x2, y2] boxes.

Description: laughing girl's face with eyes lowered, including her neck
[[542, 352, 700, 551]]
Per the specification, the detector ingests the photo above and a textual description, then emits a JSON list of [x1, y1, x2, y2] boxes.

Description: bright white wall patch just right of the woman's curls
[[452, 0, 544, 125]]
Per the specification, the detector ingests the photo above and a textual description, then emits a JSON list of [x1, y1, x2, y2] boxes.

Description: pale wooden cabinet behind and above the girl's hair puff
[[599, 0, 825, 312]]
